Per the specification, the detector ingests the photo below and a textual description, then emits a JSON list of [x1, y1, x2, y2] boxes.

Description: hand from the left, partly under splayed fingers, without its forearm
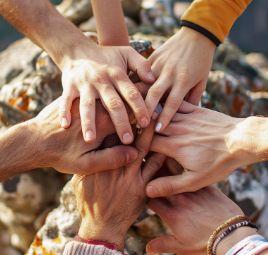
[[28, 98, 138, 174]]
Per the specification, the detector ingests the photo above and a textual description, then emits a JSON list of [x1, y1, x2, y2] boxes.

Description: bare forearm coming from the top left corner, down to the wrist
[[0, 0, 96, 66]]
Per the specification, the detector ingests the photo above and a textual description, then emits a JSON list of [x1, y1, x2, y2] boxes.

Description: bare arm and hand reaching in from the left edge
[[0, 99, 137, 181]]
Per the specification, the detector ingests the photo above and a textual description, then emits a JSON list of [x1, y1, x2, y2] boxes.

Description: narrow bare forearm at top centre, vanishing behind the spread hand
[[91, 0, 129, 46]]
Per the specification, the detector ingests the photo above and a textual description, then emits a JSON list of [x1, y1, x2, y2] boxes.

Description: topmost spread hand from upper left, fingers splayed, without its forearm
[[60, 42, 154, 144]]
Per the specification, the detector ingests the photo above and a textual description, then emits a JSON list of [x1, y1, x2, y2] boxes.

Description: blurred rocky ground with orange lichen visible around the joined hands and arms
[[0, 0, 268, 255]]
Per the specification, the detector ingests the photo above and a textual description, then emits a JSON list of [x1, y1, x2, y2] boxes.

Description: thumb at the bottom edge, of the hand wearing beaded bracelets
[[146, 235, 178, 254]]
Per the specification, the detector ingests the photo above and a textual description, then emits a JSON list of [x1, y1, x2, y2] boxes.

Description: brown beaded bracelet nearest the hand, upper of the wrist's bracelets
[[207, 215, 248, 255]]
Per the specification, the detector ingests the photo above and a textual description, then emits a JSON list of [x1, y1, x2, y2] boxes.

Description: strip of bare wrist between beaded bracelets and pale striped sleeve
[[216, 227, 257, 255]]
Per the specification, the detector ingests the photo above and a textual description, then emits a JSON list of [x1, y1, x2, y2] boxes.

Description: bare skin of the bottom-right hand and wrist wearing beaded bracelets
[[146, 187, 256, 255]]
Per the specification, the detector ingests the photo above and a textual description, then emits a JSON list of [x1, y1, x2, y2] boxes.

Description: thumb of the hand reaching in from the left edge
[[83, 145, 138, 174]]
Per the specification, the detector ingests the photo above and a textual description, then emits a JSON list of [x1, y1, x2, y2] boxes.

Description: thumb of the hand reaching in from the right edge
[[146, 171, 202, 198]]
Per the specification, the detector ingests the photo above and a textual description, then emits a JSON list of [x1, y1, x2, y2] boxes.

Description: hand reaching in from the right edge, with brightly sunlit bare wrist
[[147, 102, 267, 197]]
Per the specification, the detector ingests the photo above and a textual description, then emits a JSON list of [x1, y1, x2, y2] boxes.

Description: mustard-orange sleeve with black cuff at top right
[[181, 0, 252, 44]]
